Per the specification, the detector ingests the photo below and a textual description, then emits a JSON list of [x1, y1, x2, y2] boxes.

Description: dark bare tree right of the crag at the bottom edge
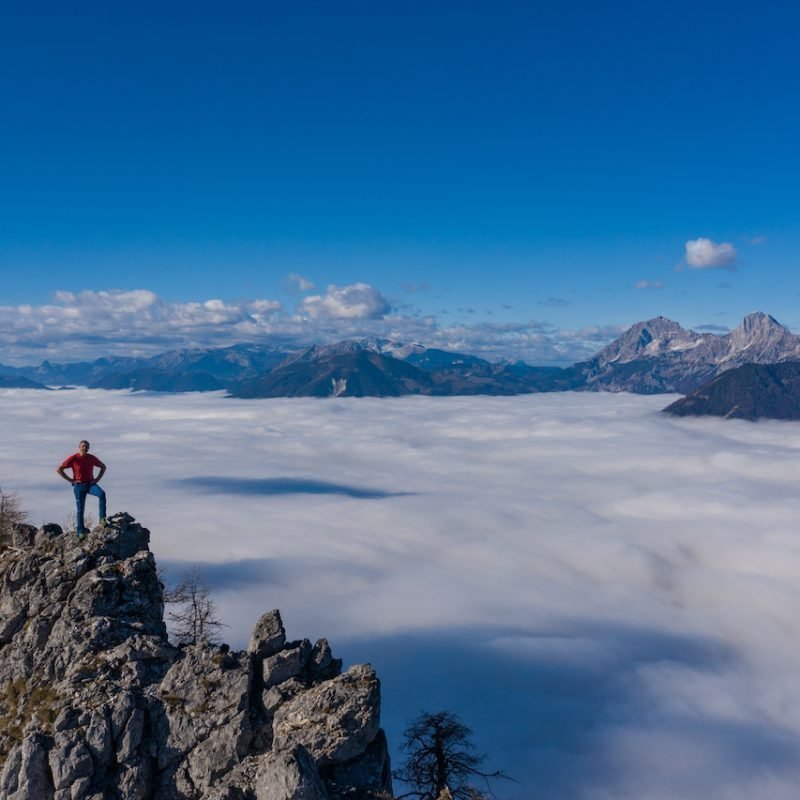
[[393, 711, 511, 800]]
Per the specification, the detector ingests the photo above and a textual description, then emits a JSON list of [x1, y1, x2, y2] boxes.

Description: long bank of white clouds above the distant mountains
[[0, 283, 622, 365]]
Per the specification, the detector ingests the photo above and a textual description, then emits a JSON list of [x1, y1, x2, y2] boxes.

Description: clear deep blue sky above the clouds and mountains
[[0, 0, 800, 362]]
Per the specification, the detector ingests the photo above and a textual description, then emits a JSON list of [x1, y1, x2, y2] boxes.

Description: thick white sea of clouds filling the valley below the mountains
[[0, 389, 800, 800]]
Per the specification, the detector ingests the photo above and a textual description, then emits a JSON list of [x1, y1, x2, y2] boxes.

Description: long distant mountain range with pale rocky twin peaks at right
[[0, 312, 800, 404]]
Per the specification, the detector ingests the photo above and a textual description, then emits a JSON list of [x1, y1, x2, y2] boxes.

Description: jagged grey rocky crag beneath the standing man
[[0, 514, 391, 800]]
